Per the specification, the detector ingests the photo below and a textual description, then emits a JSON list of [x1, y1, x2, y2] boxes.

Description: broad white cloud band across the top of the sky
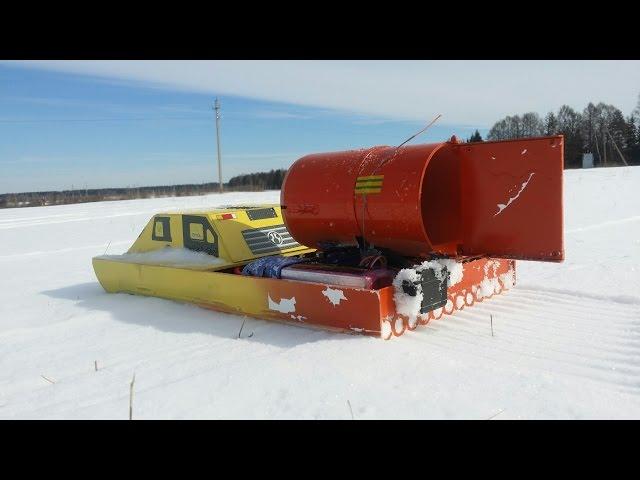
[[5, 60, 640, 127]]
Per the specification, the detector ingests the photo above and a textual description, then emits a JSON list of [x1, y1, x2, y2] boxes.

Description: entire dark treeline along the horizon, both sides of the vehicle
[[5, 95, 640, 208]]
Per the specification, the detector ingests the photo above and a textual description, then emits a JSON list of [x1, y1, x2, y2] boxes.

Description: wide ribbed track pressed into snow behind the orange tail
[[408, 288, 640, 395]]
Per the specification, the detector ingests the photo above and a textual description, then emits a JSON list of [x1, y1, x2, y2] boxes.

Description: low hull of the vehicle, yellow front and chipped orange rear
[[93, 257, 515, 339]]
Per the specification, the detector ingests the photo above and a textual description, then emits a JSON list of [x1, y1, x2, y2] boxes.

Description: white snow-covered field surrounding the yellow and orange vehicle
[[0, 167, 640, 420]]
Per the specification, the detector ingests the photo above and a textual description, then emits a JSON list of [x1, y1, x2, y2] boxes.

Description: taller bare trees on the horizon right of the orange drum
[[474, 95, 640, 168]]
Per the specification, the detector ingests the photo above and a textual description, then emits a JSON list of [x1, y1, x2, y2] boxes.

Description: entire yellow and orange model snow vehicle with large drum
[[93, 136, 564, 339]]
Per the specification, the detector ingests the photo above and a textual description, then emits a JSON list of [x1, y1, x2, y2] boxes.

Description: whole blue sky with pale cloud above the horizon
[[0, 62, 640, 193]]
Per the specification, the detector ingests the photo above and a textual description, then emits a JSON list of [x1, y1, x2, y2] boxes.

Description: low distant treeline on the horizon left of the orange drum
[[0, 170, 286, 208]]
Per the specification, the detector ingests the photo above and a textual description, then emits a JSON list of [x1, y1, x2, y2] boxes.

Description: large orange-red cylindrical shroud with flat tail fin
[[281, 136, 564, 262]]
